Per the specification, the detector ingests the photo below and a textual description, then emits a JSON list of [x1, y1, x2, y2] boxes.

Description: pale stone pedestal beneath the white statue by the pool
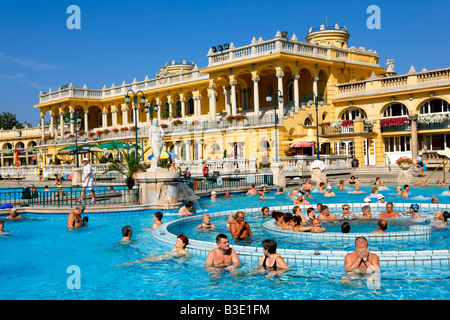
[[136, 168, 181, 209]]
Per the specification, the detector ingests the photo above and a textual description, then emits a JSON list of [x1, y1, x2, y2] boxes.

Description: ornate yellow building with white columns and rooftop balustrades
[[25, 25, 450, 170]]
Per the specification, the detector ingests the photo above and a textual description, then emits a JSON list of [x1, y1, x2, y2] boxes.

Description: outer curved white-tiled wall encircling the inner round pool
[[153, 203, 450, 268]]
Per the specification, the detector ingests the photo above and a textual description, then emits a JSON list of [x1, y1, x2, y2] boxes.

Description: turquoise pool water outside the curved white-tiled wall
[[0, 187, 450, 300]]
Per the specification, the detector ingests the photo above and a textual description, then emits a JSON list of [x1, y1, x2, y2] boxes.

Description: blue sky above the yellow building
[[0, 0, 450, 126]]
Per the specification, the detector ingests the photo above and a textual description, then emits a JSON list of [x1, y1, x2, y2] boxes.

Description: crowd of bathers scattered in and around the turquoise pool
[[0, 172, 450, 278]]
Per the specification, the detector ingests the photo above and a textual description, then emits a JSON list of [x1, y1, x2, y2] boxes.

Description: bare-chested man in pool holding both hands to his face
[[344, 237, 380, 272]]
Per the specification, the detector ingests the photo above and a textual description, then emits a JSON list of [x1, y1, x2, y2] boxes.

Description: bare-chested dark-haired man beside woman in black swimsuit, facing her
[[205, 233, 240, 270]]
